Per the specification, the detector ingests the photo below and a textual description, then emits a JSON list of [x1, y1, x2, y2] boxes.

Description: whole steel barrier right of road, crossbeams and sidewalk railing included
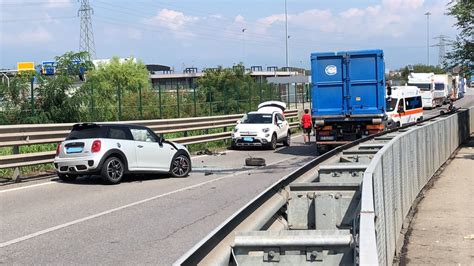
[[174, 108, 474, 265]]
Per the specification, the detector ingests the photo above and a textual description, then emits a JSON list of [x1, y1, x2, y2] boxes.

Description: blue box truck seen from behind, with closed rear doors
[[311, 50, 387, 152]]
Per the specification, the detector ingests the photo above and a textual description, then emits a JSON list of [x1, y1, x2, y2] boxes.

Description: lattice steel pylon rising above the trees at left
[[77, 0, 95, 59]]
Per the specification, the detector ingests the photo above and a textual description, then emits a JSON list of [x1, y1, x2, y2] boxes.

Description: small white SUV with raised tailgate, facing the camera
[[232, 101, 291, 150]]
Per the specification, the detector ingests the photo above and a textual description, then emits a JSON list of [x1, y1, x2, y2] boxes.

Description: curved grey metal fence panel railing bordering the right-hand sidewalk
[[359, 107, 474, 265]]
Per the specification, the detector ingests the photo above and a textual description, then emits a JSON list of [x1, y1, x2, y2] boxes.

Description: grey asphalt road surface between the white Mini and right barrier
[[0, 136, 316, 265]]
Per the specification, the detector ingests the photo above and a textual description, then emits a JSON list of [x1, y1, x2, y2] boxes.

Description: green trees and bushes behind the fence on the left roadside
[[0, 52, 279, 124]]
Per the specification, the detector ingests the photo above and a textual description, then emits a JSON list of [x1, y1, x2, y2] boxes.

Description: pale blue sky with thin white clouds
[[0, 0, 457, 71]]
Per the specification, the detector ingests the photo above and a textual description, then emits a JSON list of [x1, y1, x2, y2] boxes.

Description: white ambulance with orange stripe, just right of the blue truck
[[386, 86, 423, 127]]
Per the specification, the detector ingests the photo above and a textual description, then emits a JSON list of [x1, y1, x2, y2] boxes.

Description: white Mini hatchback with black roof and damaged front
[[54, 123, 191, 184]]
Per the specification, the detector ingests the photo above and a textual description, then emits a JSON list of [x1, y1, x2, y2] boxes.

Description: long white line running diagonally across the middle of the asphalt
[[0, 156, 295, 248]]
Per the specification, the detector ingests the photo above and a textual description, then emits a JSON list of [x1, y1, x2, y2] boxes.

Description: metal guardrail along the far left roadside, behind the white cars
[[0, 110, 299, 174]]
